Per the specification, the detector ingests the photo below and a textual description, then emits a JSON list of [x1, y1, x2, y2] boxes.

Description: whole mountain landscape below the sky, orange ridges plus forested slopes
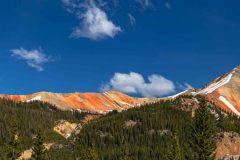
[[0, 67, 240, 160]]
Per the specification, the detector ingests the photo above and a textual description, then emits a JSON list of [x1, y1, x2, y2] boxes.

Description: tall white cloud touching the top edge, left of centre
[[62, 0, 122, 40]]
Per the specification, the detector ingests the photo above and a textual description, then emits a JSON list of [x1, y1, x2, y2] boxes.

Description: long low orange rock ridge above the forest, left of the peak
[[0, 91, 158, 113]]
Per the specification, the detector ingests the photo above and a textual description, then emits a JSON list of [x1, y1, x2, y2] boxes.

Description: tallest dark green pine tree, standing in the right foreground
[[191, 100, 216, 160]]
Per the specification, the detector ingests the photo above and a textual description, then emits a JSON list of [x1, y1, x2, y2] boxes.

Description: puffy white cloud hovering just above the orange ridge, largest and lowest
[[101, 72, 176, 97]]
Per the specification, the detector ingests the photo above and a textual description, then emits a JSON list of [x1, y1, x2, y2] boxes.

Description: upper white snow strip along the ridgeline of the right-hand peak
[[196, 73, 232, 94]]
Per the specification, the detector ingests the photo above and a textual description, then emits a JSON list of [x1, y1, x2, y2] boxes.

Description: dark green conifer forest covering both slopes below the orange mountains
[[0, 96, 240, 160]]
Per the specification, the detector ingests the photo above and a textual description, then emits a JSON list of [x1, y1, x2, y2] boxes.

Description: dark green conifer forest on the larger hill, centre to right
[[50, 96, 240, 160]]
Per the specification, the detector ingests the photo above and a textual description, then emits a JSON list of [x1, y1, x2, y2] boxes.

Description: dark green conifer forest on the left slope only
[[0, 99, 85, 157]]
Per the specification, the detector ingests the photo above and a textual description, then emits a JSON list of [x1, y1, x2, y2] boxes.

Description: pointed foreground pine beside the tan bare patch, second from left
[[32, 128, 48, 160]]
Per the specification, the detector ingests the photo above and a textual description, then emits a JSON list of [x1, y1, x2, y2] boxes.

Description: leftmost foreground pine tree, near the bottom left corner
[[5, 118, 21, 160]]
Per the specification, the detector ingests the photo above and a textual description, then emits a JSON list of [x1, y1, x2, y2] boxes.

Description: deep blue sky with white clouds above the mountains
[[0, 0, 240, 97]]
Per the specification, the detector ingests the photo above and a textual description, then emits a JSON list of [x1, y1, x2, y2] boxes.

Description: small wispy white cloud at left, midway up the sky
[[10, 48, 50, 71]]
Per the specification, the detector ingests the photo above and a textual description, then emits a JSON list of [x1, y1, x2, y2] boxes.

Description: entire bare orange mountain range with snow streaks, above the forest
[[0, 67, 240, 115]]
